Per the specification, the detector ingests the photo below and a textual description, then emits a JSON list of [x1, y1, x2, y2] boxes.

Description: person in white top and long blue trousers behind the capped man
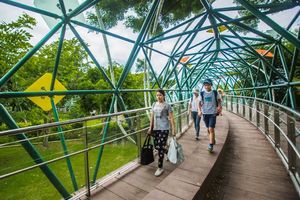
[[189, 88, 201, 140]]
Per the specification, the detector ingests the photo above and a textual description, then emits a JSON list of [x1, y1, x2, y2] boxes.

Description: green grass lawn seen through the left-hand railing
[[0, 140, 137, 200]]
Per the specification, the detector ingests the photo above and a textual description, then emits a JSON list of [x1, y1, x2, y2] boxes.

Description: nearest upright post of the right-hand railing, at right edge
[[287, 113, 296, 172]]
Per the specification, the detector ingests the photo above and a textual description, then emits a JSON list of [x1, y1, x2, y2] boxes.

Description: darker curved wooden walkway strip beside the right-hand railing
[[206, 113, 299, 200]]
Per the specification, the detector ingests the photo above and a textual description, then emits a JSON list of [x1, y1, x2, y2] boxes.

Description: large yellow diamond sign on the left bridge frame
[[25, 73, 67, 111]]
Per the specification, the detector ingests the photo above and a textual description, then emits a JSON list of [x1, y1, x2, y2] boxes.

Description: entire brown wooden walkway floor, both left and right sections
[[86, 112, 299, 200]]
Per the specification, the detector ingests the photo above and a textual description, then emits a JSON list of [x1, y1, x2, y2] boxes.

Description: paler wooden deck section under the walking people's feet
[[91, 113, 228, 200]]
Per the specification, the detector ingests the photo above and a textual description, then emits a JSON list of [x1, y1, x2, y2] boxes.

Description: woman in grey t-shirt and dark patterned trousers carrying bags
[[148, 89, 176, 176]]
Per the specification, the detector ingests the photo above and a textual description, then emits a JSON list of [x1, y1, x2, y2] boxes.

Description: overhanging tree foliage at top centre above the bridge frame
[[88, 0, 214, 33]]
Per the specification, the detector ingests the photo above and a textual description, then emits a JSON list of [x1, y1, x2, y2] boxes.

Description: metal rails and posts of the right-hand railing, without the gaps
[[226, 95, 300, 196]]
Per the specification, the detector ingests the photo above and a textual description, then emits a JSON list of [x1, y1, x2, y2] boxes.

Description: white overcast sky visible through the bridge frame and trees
[[0, 0, 300, 76]]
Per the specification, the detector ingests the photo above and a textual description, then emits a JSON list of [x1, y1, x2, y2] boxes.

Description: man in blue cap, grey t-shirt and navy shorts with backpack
[[198, 79, 222, 152]]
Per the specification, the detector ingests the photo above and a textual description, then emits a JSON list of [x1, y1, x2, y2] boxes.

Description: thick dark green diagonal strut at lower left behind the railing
[[0, 104, 71, 199]]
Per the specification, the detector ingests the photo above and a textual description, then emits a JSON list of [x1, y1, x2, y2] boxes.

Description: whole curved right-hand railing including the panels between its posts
[[224, 95, 300, 192]]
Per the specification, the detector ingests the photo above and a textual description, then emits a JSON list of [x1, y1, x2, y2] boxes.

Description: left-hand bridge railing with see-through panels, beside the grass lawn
[[0, 100, 190, 199]]
